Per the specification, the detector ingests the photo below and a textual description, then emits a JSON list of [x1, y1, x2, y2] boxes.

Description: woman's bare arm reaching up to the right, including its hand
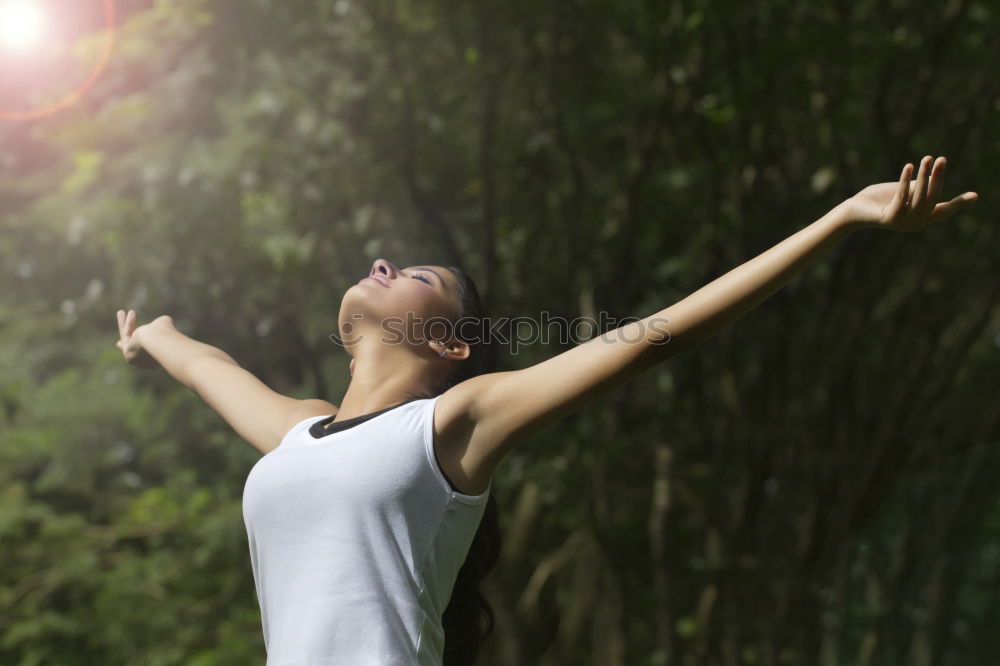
[[442, 157, 977, 478]]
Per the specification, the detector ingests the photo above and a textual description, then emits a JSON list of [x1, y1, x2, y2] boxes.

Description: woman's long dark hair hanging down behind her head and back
[[439, 266, 501, 666]]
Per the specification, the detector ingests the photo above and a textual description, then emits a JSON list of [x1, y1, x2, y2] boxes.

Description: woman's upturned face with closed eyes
[[339, 258, 460, 345]]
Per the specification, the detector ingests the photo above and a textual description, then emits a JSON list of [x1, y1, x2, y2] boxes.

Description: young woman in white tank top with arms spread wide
[[117, 156, 977, 666]]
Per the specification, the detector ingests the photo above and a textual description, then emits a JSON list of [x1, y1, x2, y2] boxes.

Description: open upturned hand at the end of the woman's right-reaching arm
[[840, 155, 979, 231]]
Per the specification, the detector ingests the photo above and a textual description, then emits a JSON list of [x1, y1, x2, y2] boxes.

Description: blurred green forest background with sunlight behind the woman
[[0, 0, 1000, 666]]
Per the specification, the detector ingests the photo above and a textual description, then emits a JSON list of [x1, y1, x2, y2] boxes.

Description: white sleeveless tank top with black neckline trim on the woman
[[243, 396, 493, 666]]
